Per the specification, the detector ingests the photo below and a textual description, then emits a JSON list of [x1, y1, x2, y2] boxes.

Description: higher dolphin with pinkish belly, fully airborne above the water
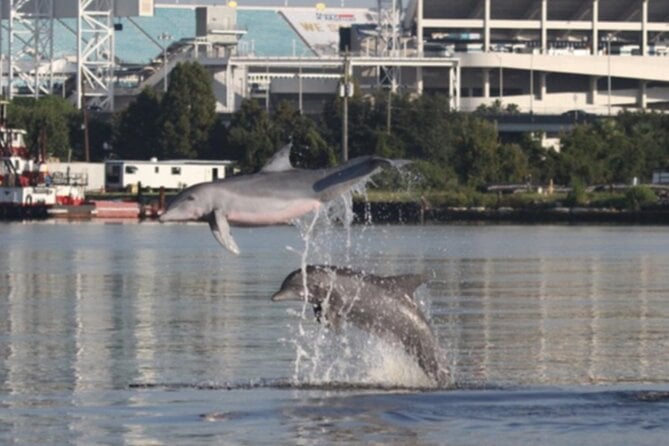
[[159, 144, 409, 254]]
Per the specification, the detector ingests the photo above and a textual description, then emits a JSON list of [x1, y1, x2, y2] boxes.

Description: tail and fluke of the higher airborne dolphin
[[314, 156, 411, 201]]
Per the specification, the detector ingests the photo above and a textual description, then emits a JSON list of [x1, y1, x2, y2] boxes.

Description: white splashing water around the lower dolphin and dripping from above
[[288, 185, 444, 388]]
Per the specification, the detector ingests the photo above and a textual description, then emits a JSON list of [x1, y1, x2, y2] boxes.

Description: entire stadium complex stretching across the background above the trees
[[0, 0, 669, 116]]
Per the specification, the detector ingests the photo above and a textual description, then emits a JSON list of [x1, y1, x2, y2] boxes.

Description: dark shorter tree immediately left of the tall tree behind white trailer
[[114, 88, 162, 159]]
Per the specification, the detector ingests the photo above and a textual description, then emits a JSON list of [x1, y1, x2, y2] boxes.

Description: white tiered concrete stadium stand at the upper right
[[403, 0, 669, 114]]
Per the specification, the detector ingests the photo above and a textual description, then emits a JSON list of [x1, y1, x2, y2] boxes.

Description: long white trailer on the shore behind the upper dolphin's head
[[105, 158, 232, 191]]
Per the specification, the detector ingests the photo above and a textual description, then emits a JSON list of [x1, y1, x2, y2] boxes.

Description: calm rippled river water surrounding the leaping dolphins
[[0, 221, 669, 445]]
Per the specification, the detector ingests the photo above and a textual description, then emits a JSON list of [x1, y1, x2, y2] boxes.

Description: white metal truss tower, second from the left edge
[[77, 0, 115, 110]]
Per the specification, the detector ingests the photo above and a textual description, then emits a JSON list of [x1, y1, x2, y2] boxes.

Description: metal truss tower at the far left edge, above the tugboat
[[0, 0, 54, 100]]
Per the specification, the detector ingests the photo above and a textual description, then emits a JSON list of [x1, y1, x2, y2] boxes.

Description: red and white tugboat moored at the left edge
[[0, 101, 88, 219]]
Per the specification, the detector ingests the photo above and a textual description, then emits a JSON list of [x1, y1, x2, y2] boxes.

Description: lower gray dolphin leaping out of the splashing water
[[272, 265, 449, 387]]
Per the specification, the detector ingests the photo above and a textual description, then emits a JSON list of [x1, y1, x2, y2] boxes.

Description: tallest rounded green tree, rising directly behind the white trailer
[[161, 62, 216, 158]]
